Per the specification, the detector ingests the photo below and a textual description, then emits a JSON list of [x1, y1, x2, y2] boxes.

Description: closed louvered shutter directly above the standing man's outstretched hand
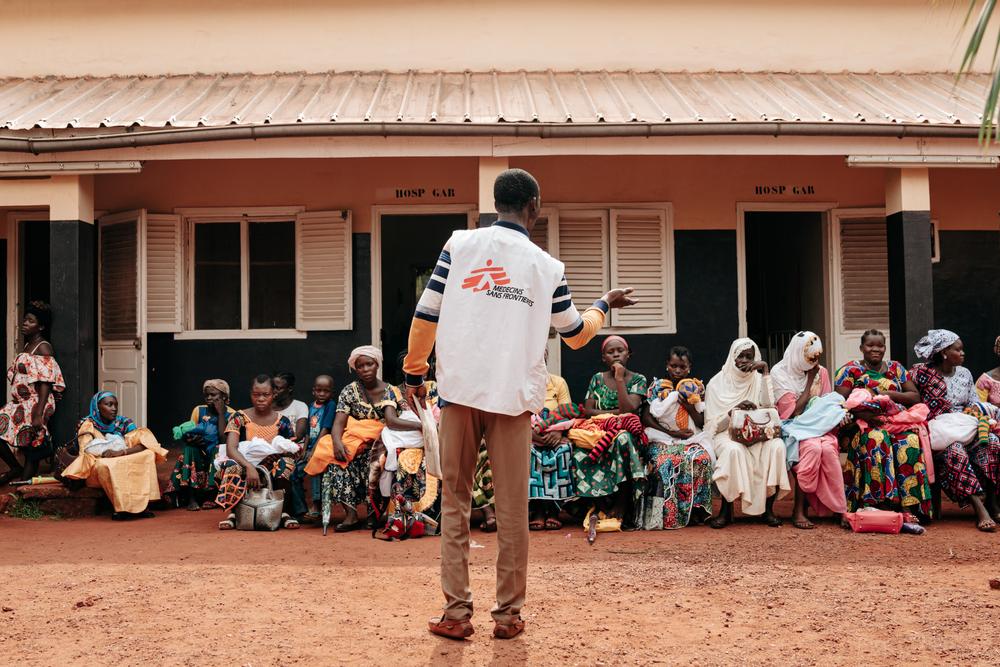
[[611, 209, 673, 327]]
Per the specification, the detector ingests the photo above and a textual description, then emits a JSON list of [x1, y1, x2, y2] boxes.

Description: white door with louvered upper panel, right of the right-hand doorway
[[827, 208, 891, 371]]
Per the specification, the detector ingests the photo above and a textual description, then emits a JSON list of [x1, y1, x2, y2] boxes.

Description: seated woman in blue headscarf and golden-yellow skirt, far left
[[63, 391, 167, 521]]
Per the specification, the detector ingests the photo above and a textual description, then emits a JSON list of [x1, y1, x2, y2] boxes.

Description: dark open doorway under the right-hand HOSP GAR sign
[[744, 211, 826, 366]]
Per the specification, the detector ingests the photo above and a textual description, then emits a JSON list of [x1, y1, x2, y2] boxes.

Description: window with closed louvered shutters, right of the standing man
[[531, 204, 676, 333]]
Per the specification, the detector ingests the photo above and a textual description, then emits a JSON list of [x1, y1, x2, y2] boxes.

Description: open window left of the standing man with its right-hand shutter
[[176, 207, 352, 337]]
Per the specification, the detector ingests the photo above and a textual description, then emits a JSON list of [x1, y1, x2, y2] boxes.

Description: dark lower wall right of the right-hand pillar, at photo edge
[[932, 231, 1000, 378]]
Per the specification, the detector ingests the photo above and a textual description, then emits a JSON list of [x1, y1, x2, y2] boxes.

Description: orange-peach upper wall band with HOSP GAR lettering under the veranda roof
[[95, 156, 1000, 232]]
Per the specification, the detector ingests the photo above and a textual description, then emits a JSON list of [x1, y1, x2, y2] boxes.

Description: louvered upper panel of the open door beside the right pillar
[[840, 218, 889, 331]]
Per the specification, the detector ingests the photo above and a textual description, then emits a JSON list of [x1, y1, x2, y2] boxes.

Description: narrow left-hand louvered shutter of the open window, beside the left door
[[146, 213, 184, 332]]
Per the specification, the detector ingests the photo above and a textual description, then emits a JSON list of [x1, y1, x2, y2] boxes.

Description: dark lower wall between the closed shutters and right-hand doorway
[[562, 230, 739, 402]]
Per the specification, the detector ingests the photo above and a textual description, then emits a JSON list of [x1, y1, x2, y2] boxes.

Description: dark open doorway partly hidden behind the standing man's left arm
[[379, 213, 469, 382]]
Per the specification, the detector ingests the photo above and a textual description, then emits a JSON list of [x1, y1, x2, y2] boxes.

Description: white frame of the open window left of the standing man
[[174, 206, 306, 340]]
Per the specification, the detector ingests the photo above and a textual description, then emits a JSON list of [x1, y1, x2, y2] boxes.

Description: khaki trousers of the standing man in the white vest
[[441, 405, 531, 623]]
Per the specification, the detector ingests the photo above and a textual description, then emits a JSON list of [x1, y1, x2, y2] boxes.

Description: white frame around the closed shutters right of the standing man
[[540, 201, 677, 335]]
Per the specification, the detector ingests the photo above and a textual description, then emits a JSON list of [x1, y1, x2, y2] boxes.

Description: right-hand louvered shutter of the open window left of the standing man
[[295, 211, 353, 331]]
